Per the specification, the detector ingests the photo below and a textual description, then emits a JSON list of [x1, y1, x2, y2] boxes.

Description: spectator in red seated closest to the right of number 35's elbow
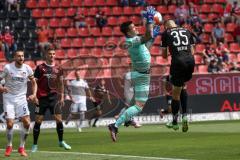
[[202, 44, 217, 65]]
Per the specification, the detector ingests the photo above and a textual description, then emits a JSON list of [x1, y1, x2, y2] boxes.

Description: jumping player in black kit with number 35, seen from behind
[[161, 20, 195, 132]]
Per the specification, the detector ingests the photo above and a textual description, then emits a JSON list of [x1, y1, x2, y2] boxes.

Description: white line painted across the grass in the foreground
[[0, 149, 189, 160]]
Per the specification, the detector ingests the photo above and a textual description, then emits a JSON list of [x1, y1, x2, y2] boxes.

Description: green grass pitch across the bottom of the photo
[[0, 121, 240, 160]]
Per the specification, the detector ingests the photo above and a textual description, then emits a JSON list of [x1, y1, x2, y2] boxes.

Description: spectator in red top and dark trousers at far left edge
[[2, 26, 17, 61]]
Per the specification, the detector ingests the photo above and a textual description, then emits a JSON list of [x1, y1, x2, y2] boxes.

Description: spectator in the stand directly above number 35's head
[[174, 4, 189, 26]]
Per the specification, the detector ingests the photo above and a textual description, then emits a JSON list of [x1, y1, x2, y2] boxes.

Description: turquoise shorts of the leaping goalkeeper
[[131, 71, 150, 103]]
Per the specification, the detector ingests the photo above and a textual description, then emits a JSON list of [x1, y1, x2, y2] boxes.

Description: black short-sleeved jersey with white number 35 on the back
[[162, 27, 194, 59]]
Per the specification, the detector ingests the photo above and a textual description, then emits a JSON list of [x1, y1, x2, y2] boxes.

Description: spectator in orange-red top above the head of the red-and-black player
[[37, 26, 50, 56]]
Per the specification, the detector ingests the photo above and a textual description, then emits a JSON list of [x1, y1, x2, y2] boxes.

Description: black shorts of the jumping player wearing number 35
[[170, 55, 195, 87]]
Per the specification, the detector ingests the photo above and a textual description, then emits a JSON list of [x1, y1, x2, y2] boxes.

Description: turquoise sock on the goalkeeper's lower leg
[[115, 105, 142, 128]]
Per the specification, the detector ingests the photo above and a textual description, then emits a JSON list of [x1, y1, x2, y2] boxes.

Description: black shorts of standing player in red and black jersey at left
[[35, 94, 62, 115]]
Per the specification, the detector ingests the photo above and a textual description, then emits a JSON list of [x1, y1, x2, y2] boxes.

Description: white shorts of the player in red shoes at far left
[[3, 96, 30, 119]]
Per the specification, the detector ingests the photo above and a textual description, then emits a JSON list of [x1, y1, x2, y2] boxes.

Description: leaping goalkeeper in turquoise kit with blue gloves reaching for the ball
[[108, 6, 160, 142]]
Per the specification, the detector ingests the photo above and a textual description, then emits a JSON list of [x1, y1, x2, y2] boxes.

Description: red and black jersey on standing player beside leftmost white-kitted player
[[34, 63, 63, 98]]
